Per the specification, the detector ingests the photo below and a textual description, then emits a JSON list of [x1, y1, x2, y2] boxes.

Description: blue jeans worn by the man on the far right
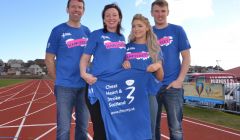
[[156, 86, 184, 140]]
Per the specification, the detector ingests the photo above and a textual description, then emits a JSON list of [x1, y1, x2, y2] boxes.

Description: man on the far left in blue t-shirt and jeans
[[45, 0, 90, 140]]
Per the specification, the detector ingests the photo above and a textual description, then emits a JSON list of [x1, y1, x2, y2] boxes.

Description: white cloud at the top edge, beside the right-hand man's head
[[168, 0, 214, 23]]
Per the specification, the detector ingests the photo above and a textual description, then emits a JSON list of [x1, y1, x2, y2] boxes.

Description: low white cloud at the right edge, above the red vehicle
[[189, 22, 240, 69]]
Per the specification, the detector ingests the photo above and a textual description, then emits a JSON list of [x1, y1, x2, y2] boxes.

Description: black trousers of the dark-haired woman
[[85, 86, 106, 140]]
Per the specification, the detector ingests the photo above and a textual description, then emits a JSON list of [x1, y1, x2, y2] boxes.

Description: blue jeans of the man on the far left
[[54, 85, 89, 140]]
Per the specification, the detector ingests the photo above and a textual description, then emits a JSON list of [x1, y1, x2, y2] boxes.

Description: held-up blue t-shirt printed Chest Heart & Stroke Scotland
[[88, 69, 156, 140]]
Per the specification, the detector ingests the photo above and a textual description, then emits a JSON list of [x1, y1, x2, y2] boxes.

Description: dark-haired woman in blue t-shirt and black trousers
[[80, 4, 126, 140]]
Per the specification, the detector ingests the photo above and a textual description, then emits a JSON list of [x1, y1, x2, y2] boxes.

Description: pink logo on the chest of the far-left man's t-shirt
[[66, 38, 88, 48]]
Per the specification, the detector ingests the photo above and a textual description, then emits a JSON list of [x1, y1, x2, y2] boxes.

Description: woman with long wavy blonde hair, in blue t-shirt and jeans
[[123, 14, 164, 140]]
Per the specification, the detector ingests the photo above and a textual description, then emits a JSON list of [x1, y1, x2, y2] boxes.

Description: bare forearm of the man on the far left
[[45, 53, 56, 80]]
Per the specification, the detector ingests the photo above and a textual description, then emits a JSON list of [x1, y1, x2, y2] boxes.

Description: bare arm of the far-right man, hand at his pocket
[[168, 49, 191, 88]]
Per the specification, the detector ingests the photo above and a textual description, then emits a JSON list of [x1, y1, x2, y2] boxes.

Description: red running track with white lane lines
[[0, 80, 240, 140]]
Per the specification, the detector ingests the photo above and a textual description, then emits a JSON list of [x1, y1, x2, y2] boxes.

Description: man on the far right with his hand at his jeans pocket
[[151, 0, 191, 140]]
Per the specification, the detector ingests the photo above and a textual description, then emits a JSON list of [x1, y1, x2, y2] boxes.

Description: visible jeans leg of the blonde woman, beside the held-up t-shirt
[[148, 95, 158, 140]]
